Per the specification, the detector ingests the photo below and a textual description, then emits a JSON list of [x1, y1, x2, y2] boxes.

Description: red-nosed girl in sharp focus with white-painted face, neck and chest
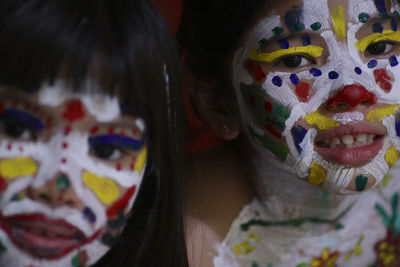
[[180, 0, 400, 267]]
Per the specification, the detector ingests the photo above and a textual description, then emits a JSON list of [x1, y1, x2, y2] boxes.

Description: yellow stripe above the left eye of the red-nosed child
[[248, 45, 324, 62]]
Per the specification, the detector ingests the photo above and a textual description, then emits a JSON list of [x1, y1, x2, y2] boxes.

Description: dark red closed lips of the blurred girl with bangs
[[0, 214, 100, 259]]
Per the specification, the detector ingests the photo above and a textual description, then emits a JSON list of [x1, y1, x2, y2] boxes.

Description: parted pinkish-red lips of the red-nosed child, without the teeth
[[315, 122, 386, 165]]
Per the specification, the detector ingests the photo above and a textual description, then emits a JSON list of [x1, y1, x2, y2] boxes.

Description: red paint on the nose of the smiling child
[[327, 84, 376, 110]]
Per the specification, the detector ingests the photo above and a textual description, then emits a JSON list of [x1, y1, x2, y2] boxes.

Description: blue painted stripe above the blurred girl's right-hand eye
[[89, 134, 144, 151]]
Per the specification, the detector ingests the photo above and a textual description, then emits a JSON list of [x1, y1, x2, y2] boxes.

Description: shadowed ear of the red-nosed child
[[183, 70, 240, 140]]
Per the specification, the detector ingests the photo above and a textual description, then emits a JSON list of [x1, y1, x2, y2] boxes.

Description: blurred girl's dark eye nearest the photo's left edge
[[0, 118, 36, 141]]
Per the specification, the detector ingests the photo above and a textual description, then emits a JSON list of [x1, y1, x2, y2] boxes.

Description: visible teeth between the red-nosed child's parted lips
[[318, 134, 376, 148]]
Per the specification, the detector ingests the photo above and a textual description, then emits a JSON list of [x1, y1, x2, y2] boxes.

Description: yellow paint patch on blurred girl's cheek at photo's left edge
[[0, 158, 38, 179]]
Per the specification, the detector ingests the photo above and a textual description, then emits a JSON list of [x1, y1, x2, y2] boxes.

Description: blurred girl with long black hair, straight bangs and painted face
[[0, 0, 186, 267]]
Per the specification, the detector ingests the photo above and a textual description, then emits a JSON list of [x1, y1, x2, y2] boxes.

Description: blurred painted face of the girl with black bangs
[[0, 81, 146, 267]]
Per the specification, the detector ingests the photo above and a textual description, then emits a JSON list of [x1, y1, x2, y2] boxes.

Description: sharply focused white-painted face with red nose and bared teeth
[[233, 0, 400, 194]]
